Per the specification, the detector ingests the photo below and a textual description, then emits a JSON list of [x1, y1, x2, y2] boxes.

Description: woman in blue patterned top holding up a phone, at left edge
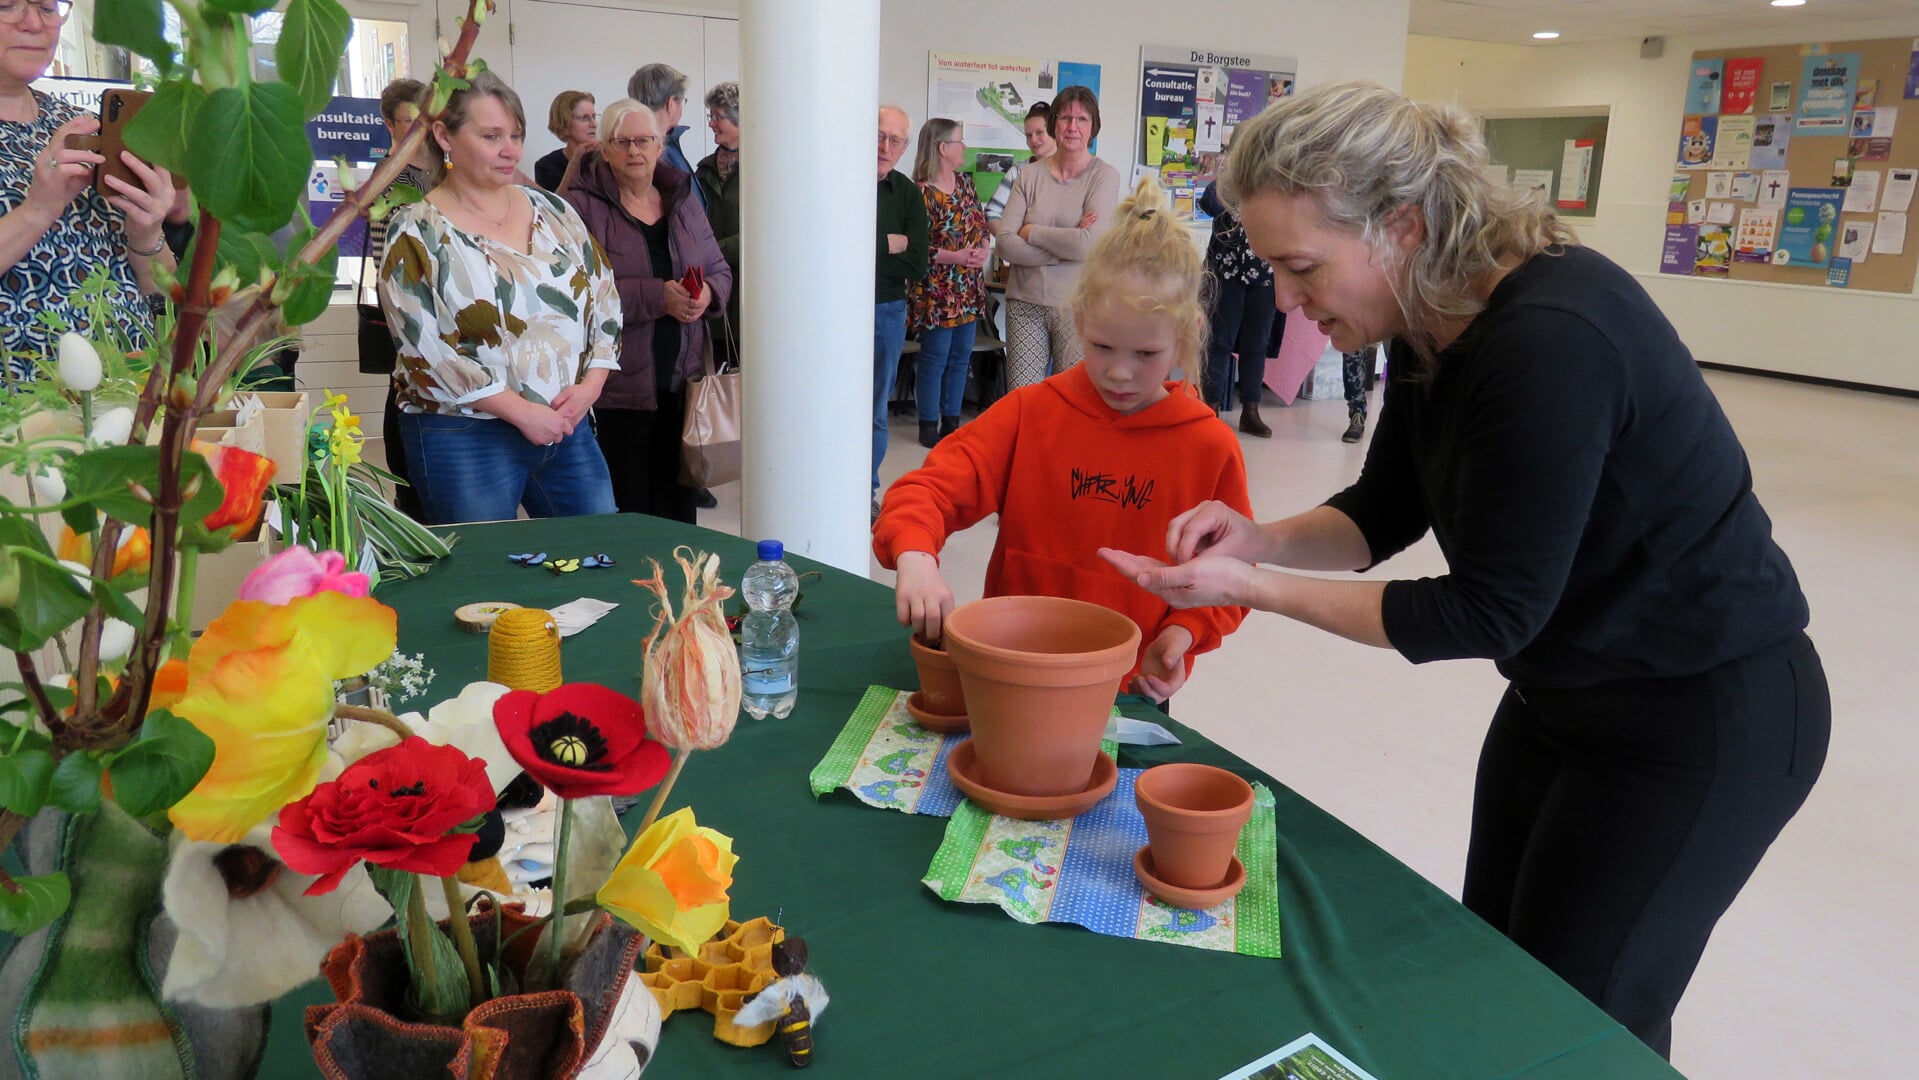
[[0, 0, 173, 378]]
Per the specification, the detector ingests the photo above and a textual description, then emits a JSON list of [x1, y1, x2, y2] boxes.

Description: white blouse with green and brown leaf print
[[380, 188, 622, 418]]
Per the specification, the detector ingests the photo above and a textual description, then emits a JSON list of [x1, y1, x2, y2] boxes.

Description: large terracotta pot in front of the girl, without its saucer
[[946, 597, 1140, 796]]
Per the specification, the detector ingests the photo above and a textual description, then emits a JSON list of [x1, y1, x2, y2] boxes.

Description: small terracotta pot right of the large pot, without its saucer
[[1132, 762, 1253, 888]]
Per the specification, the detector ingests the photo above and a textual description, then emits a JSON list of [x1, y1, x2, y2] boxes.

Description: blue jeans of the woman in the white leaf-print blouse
[[399, 408, 616, 526]]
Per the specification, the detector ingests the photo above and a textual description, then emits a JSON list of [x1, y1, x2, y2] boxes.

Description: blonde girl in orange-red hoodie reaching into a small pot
[[873, 178, 1249, 702]]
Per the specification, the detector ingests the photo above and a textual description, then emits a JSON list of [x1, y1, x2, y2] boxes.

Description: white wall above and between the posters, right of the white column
[[879, 0, 1407, 176]]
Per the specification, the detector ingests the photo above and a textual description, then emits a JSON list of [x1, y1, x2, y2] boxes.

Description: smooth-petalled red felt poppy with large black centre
[[493, 683, 672, 798]]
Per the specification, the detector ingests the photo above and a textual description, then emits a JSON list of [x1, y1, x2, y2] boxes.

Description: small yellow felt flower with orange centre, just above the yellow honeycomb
[[597, 808, 739, 953]]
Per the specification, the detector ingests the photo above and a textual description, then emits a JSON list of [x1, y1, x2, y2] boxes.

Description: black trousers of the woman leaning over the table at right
[[1464, 635, 1833, 1057]]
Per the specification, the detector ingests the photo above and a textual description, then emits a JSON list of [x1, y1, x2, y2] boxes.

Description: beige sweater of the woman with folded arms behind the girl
[[994, 157, 1119, 307]]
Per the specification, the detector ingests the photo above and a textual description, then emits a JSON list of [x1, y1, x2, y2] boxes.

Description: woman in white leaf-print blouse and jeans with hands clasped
[[380, 73, 622, 524]]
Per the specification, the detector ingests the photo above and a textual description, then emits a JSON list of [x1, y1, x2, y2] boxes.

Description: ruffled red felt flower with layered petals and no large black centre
[[272, 737, 493, 896]]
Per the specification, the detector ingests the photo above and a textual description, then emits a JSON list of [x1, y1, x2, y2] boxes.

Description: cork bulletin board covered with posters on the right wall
[[1660, 36, 1919, 295]]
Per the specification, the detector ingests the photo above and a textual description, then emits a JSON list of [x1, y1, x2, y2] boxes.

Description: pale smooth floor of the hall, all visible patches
[[381, 374, 1919, 1080]]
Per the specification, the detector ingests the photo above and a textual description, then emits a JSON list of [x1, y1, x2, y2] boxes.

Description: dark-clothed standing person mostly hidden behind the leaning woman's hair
[[1199, 184, 1282, 439]]
